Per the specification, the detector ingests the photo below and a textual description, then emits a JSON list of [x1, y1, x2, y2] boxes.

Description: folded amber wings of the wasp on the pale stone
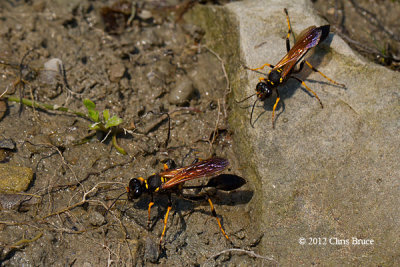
[[273, 25, 330, 77]]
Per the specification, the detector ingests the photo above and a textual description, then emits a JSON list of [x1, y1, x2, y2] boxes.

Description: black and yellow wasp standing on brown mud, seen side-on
[[127, 157, 246, 246]]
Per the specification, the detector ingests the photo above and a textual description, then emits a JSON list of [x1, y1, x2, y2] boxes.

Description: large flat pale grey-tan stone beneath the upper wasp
[[188, 0, 400, 266]]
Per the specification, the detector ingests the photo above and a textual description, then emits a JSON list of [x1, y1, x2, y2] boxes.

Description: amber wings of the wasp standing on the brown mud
[[160, 158, 229, 189]]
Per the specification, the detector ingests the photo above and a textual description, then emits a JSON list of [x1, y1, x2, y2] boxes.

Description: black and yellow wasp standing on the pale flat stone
[[242, 8, 344, 128]]
